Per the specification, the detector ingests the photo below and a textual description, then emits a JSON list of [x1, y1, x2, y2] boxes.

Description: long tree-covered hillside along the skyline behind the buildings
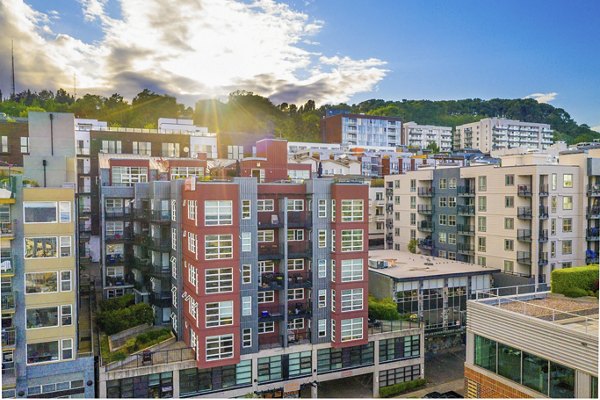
[[0, 89, 600, 144]]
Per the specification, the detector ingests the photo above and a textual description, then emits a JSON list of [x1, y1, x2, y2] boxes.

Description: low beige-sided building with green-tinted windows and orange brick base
[[465, 292, 598, 399]]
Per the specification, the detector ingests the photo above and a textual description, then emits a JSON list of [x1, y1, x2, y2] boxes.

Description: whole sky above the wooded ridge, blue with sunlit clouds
[[0, 0, 600, 131]]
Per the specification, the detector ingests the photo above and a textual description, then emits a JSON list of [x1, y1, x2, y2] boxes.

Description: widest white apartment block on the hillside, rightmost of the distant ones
[[454, 118, 553, 153]]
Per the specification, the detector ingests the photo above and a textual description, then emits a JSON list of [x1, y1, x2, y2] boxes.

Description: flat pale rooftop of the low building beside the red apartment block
[[369, 250, 500, 280]]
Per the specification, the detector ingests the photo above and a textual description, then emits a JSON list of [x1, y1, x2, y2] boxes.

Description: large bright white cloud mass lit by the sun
[[0, 0, 388, 104]]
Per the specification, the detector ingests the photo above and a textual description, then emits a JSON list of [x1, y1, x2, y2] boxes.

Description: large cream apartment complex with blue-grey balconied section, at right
[[385, 149, 600, 283]]
